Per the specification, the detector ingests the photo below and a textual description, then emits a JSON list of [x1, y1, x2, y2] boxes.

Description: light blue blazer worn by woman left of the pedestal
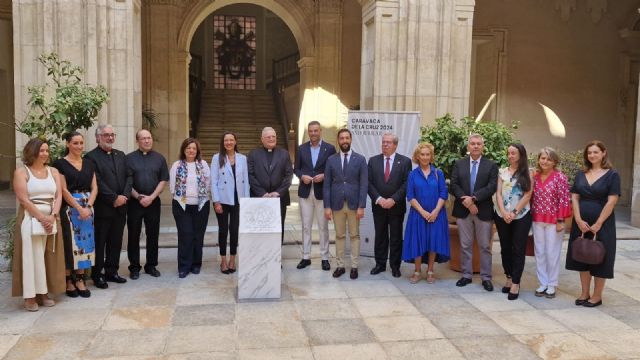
[[211, 153, 249, 205]]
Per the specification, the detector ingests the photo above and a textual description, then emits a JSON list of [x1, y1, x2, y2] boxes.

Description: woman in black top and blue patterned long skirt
[[53, 131, 98, 298]]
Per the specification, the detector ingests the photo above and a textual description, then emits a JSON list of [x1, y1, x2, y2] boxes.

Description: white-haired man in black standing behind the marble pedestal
[[247, 127, 293, 242]]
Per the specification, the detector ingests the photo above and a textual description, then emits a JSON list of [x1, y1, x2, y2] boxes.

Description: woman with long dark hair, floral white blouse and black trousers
[[494, 143, 531, 300]]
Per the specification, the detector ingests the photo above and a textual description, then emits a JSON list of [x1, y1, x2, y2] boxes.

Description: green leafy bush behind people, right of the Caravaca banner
[[420, 114, 518, 179]]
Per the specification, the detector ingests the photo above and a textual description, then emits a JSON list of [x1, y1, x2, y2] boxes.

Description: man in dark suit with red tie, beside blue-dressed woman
[[369, 133, 411, 277]]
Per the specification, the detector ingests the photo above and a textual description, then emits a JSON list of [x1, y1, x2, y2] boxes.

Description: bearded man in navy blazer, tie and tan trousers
[[323, 129, 368, 279]]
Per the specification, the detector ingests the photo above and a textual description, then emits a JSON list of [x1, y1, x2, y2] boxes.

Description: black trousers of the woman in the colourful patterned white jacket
[[171, 200, 211, 272]]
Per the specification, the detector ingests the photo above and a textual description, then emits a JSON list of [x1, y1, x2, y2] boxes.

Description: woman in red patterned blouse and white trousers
[[531, 147, 571, 299]]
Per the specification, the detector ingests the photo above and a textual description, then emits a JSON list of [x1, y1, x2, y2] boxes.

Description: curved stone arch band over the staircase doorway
[[178, 0, 314, 58]]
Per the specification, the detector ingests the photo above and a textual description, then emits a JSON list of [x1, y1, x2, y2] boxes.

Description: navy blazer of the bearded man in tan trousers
[[323, 151, 369, 211]]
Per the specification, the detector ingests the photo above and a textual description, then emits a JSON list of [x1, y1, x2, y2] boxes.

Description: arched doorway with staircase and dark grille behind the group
[[178, 0, 314, 160]]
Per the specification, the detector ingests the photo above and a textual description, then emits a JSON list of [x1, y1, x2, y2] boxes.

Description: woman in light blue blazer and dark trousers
[[211, 131, 249, 274]]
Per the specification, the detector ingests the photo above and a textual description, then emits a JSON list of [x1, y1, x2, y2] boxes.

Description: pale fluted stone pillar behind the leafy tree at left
[[13, 0, 141, 151]]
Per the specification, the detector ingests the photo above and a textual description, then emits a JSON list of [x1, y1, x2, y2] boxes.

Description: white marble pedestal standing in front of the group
[[238, 198, 282, 299]]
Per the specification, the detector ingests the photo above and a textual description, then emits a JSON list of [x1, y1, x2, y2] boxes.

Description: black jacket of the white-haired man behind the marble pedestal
[[247, 147, 293, 206]]
